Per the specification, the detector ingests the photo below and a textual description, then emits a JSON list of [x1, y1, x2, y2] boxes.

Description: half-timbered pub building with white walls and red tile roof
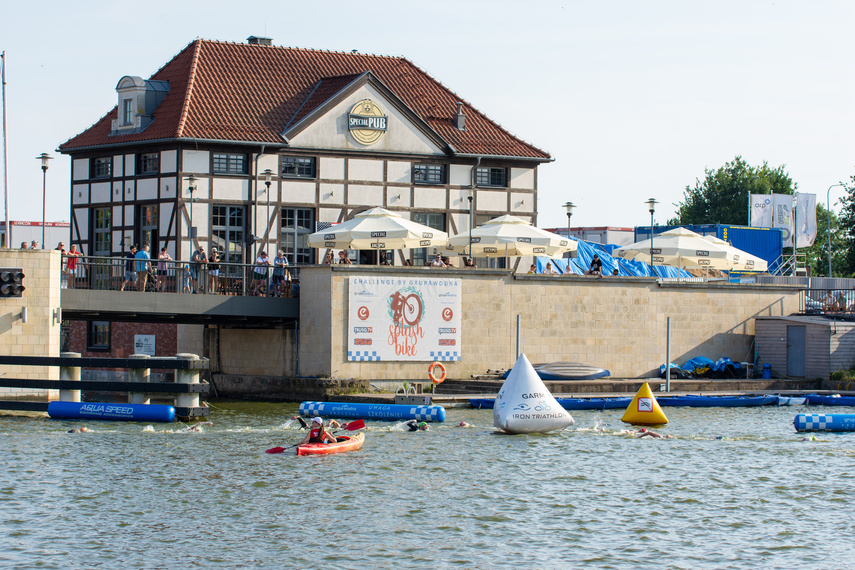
[[60, 37, 552, 265]]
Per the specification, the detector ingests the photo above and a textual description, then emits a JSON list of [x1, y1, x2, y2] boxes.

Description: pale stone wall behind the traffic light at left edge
[[0, 249, 61, 395]]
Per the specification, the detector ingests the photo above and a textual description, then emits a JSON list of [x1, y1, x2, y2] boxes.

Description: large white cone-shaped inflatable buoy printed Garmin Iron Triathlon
[[493, 354, 573, 433]]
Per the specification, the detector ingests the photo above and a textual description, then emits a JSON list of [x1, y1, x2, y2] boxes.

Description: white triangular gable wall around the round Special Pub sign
[[291, 85, 444, 155]]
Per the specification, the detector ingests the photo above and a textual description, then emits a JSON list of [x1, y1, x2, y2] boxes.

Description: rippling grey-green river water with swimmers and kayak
[[0, 403, 855, 570]]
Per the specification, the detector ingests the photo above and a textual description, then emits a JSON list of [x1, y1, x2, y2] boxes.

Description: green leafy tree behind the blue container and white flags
[[668, 156, 798, 226]]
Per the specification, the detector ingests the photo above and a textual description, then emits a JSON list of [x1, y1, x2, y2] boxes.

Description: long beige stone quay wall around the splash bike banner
[[299, 266, 799, 380]]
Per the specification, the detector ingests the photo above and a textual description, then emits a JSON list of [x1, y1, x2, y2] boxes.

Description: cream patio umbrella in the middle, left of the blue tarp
[[445, 215, 577, 257]]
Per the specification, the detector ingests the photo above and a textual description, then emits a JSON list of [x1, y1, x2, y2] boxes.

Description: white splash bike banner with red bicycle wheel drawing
[[347, 275, 463, 362]]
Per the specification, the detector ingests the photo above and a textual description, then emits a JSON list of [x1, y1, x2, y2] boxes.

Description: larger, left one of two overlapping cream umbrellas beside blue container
[[613, 228, 734, 269]]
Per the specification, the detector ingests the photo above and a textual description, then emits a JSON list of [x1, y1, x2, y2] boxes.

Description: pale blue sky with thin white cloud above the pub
[[0, 0, 855, 228]]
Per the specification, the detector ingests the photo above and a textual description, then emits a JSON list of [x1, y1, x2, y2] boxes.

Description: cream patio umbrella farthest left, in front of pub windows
[[308, 208, 448, 250]]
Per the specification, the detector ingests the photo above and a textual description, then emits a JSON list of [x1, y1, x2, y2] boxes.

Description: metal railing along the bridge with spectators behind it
[[62, 255, 300, 298]]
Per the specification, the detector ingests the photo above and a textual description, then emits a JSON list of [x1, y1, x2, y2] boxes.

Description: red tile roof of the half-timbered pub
[[60, 40, 551, 160]]
